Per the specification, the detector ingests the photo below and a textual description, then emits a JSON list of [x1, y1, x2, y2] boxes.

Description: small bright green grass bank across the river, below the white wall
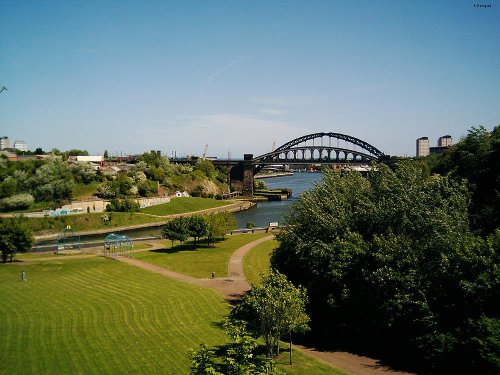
[[141, 197, 233, 216]]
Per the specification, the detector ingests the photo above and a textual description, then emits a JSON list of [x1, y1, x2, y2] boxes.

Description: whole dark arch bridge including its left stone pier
[[229, 133, 388, 195]]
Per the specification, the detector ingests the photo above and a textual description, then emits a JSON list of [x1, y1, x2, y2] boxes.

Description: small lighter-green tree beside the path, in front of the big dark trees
[[234, 270, 309, 364]]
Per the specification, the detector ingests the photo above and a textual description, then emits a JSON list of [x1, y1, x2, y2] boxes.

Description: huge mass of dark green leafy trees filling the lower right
[[272, 162, 500, 373]]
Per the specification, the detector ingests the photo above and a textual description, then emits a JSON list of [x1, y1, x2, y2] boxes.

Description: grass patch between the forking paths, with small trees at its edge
[[135, 233, 267, 278]]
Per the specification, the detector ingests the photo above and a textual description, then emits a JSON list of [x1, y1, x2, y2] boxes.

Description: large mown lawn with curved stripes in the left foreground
[[0, 258, 228, 374]]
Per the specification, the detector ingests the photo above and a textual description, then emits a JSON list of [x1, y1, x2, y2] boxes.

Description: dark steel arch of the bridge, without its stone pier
[[253, 133, 385, 169]]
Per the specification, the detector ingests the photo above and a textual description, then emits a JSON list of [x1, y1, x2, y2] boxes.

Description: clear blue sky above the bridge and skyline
[[0, 0, 500, 158]]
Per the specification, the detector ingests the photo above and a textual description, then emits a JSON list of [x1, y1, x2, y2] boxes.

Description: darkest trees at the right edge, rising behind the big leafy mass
[[430, 126, 500, 235]]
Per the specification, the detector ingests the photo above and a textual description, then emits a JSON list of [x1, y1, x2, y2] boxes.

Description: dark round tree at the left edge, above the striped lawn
[[0, 218, 33, 263]]
